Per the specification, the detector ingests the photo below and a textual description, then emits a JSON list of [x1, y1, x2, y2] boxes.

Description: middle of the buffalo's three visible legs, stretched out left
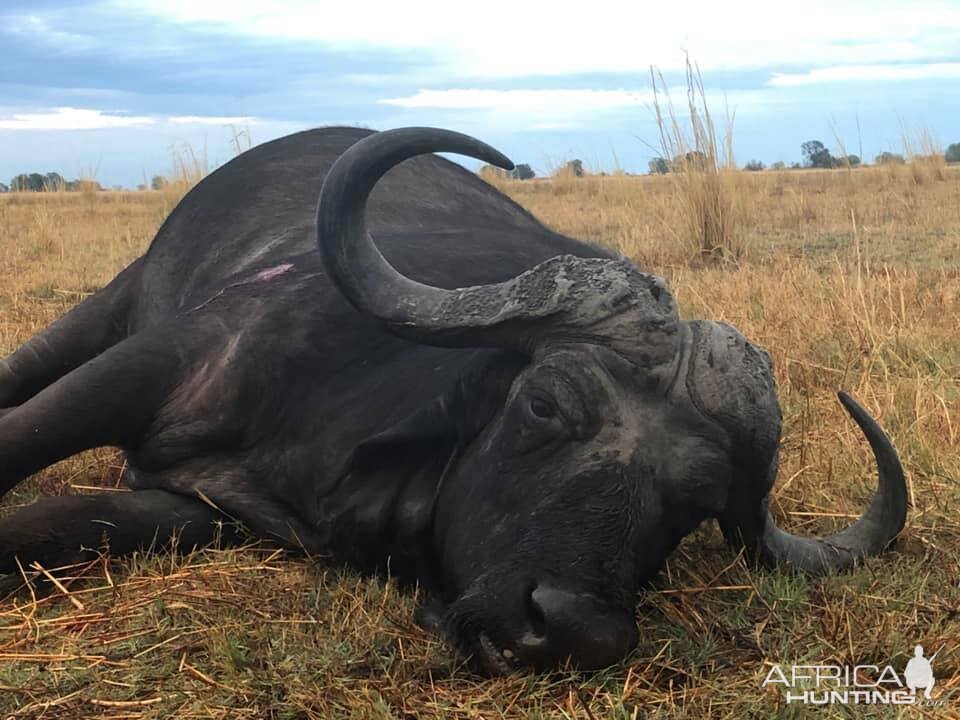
[[0, 329, 181, 496]]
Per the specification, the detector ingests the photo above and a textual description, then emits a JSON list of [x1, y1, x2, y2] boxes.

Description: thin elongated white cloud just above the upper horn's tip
[[379, 88, 653, 114]]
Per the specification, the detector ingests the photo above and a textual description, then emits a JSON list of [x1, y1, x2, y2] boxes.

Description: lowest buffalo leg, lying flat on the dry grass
[[0, 490, 241, 579]]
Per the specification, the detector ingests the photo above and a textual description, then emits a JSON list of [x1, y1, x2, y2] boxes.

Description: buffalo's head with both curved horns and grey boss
[[317, 128, 906, 672]]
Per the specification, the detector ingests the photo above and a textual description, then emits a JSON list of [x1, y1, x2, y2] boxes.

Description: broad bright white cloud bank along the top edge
[[108, 0, 960, 78]]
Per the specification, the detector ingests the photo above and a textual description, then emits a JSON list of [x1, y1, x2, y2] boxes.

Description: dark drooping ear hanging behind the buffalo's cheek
[[325, 350, 528, 580]]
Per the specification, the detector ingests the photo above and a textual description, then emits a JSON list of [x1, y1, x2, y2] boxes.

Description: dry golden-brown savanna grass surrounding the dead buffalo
[[0, 160, 960, 719]]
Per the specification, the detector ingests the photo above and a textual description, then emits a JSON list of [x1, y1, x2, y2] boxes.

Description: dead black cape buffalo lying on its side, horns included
[[0, 128, 906, 673]]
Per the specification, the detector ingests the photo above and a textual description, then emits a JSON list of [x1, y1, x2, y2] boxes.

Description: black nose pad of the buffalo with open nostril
[[518, 584, 638, 670]]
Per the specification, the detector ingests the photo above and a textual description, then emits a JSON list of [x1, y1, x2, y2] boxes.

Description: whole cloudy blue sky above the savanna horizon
[[0, 0, 960, 187]]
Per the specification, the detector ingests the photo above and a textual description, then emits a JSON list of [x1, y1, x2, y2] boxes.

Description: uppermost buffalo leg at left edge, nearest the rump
[[0, 260, 140, 414]]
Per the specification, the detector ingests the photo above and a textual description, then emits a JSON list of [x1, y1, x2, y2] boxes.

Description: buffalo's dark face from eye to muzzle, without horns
[[435, 345, 730, 667]]
